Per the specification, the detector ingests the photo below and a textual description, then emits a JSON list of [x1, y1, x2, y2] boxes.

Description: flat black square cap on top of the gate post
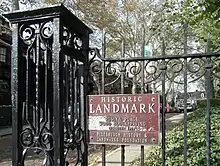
[[3, 4, 92, 33]]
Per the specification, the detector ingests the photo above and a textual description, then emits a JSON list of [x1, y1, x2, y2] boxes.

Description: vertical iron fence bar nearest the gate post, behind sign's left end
[[101, 30, 106, 166]]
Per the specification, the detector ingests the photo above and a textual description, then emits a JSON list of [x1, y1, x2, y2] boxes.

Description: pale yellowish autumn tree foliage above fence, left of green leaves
[[43, 0, 167, 57]]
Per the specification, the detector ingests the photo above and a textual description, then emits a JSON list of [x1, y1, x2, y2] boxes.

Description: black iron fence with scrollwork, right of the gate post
[[90, 31, 220, 166]]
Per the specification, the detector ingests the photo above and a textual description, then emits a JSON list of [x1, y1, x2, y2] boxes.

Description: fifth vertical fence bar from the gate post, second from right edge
[[183, 23, 188, 166]]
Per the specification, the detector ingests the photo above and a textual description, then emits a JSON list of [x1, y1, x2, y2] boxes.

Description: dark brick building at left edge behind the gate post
[[0, 16, 12, 126]]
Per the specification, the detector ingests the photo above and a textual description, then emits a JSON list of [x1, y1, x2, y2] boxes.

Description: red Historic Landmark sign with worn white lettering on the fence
[[88, 94, 160, 145]]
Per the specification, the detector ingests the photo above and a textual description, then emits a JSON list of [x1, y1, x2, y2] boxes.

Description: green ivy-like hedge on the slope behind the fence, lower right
[[133, 107, 220, 166]]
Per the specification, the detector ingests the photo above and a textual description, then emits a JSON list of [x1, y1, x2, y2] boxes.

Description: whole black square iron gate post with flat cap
[[5, 5, 92, 166]]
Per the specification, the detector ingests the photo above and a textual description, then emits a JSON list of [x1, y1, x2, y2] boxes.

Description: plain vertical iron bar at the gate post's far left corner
[[11, 24, 22, 166]]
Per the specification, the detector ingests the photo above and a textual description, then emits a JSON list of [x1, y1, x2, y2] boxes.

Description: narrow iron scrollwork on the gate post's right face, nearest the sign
[[63, 27, 85, 165]]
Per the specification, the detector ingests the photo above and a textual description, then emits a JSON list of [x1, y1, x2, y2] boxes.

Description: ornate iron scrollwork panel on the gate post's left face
[[19, 21, 54, 165]]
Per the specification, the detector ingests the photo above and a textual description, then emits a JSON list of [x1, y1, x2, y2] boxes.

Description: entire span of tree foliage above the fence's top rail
[[2, 0, 220, 53]]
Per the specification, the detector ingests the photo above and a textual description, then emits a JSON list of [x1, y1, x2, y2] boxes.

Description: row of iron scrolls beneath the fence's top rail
[[90, 48, 220, 94]]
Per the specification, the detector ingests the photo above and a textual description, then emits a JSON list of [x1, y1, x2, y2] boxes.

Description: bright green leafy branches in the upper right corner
[[160, 0, 220, 51]]
